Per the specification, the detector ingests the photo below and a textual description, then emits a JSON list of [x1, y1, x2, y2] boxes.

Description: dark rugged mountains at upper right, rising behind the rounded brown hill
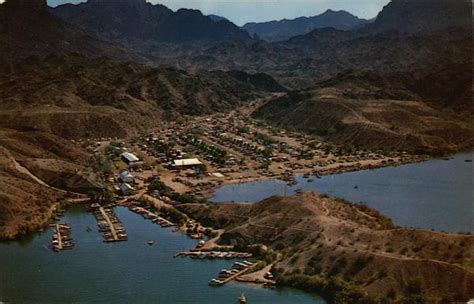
[[168, 0, 472, 110]]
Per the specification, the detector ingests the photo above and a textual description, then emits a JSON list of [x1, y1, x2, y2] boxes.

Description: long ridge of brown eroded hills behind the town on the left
[[0, 55, 283, 138]]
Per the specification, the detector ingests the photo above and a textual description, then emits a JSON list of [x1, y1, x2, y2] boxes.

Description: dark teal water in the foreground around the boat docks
[[0, 206, 325, 304]]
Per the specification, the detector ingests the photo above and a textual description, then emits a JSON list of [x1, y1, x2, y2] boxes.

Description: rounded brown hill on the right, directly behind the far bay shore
[[253, 83, 474, 155]]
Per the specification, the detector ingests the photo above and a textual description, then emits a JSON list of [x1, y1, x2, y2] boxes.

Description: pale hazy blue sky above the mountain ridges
[[46, 0, 390, 25]]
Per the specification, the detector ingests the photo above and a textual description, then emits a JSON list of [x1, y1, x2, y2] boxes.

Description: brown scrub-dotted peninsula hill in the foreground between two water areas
[[178, 193, 474, 303]]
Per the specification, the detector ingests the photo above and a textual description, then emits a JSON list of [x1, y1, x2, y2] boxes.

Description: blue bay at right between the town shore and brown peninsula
[[211, 153, 474, 232]]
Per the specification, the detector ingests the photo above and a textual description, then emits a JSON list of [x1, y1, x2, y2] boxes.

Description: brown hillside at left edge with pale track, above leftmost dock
[[0, 128, 96, 239]]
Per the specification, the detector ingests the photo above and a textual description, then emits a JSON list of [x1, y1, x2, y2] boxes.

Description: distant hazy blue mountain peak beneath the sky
[[242, 10, 370, 41]]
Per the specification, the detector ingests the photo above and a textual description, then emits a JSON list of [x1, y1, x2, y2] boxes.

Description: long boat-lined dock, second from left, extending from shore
[[92, 206, 128, 242]]
